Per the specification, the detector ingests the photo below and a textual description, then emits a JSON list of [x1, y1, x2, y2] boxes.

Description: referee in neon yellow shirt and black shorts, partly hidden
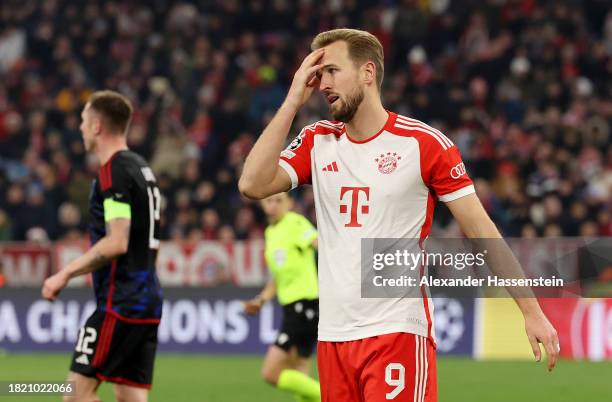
[[245, 192, 321, 402]]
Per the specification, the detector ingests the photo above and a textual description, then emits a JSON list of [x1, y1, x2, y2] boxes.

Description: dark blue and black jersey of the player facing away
[[89, 151, 162, 322]]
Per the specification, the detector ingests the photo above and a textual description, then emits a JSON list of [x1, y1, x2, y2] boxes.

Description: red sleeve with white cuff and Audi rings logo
[[421, 144, 474, 202]]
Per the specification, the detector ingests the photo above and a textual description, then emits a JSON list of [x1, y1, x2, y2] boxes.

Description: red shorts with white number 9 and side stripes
[[317, 333, 438, 402]]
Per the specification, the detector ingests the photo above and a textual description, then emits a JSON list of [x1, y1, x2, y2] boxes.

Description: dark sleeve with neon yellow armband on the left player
[[99, 160, 132, 222]]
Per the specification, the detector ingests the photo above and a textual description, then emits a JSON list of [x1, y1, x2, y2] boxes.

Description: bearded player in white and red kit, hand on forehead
[[239, 29, 558, 402]]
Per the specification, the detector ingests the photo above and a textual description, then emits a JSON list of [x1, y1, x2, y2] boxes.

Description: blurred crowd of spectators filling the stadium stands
[[0, 0, 612, 241]]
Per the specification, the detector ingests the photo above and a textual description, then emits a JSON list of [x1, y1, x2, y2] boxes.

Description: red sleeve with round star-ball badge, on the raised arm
[[278, 127, 312, 189]]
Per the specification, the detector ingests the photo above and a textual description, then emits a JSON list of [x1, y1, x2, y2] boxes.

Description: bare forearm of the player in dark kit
[[64, 236, 127, 279]]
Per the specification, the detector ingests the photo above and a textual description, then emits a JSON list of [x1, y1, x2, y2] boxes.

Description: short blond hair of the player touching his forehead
[[310, 28, 385, 91]]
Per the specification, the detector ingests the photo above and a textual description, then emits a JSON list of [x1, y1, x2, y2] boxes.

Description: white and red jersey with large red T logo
[[279, 112, 474, 341]]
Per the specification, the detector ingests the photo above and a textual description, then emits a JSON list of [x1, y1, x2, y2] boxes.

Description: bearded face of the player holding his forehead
[[319, 41, 364, 123]]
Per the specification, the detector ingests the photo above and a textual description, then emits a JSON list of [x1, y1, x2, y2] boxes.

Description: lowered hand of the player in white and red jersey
[[525, 312, 561, 371]]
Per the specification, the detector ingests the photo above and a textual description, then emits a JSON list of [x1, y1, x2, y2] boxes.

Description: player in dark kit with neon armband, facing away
[[42, 91, 162, 402]]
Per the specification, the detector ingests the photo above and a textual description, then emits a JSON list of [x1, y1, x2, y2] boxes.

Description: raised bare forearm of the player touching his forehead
[[238, 102, 298, 196]]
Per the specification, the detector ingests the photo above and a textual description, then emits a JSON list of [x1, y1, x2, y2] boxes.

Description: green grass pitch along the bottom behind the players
[[0, 354, 612, 402]]
